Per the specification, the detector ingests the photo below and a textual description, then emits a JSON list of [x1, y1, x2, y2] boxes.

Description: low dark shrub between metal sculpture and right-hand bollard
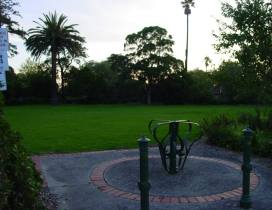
[[202, 114, 241, 150]]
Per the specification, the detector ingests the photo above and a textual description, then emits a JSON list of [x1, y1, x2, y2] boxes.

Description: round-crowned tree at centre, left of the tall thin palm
[[125, 26, 183, 104]]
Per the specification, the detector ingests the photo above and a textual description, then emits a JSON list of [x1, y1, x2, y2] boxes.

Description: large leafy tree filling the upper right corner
[[215, 0, 272, 102]]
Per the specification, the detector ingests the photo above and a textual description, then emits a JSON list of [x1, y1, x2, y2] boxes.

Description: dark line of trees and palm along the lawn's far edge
[[0, 0, 272, 104]]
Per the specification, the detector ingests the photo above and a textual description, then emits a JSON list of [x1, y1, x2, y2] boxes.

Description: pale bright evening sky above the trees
[[9, 0, 230, 70]]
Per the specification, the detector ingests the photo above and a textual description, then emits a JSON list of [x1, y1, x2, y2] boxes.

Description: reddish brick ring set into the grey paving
[[90, 155, 259, 204]]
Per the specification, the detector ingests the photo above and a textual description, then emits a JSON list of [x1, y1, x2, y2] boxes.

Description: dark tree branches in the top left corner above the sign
[[0, 0, 25, 55]]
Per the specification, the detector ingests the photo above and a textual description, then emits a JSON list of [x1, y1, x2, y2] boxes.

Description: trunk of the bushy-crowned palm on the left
[[51, 47, 58, 105]]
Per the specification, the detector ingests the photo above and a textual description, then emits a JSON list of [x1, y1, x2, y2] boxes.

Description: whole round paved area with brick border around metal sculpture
[[91, 155, 259, 204]]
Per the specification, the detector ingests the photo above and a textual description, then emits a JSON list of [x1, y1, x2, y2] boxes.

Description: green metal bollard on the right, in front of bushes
[[240, 128, 254, 209]]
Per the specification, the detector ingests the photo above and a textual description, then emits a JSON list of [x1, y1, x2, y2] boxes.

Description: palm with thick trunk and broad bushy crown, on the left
[[25, 12, 85, 104]]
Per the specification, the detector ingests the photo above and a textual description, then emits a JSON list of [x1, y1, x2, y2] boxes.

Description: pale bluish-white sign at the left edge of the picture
[[0, 28, 9, 91]]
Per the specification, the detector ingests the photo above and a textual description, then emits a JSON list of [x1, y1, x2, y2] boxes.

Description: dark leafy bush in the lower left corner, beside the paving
[[0, 94, 45, 210]]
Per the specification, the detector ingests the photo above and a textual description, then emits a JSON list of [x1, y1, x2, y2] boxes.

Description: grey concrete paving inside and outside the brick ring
[[34, 141, 272, 210]]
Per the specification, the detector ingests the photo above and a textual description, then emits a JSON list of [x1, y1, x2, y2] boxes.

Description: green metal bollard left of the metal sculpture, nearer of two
[[138, 136, 151, 210]]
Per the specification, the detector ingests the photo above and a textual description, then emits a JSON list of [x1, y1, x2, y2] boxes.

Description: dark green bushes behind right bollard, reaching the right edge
[[202, 109, 272, 158]]
